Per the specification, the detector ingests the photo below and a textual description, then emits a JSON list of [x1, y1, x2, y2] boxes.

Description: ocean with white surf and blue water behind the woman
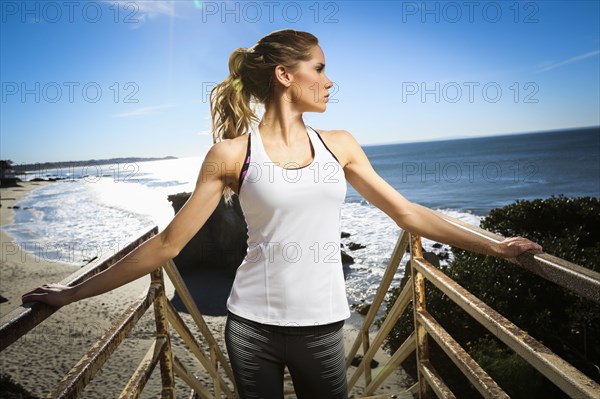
[[2, 127, 600, 303]]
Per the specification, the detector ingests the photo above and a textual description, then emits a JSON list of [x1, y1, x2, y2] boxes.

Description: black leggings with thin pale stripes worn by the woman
[[225, 313, 348, 399]]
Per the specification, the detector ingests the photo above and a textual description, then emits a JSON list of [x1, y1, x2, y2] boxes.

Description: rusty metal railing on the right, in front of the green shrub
[[346, 213, 600, 399]]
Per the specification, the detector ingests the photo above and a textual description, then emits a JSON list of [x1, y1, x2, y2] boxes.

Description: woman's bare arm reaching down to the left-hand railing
[[22, 142, 237, 306]]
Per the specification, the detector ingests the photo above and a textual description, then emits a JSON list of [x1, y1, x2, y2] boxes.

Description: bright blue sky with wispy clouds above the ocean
[[0, 0, 600, 163]]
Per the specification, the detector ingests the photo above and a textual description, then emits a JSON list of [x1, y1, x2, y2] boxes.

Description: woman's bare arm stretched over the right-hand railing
[[325, 131, 542, 258]]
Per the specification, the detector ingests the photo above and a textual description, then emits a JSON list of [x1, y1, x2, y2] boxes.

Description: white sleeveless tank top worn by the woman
[[227, 125, 350, 326]]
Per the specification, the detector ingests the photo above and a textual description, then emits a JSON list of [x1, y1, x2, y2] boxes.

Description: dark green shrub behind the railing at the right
[[380, 196, 600, 398]]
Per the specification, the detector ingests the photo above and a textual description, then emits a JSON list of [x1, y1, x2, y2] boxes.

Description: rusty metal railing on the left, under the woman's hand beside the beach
[[0, 227, 238, 399]]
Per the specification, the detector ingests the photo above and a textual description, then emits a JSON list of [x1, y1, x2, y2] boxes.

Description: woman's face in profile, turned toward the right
[[284, 46, 333, 112]]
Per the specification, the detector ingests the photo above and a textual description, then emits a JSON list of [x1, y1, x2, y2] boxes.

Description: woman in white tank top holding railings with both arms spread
[[23, 29, 541, 399]]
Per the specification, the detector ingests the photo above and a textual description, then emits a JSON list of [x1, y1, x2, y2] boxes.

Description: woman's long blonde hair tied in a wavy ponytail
[[210, 29, 319, 202]]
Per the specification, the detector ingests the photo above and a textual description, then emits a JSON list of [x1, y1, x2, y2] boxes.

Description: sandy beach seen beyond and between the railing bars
[[0, 182, 404, 399]]
